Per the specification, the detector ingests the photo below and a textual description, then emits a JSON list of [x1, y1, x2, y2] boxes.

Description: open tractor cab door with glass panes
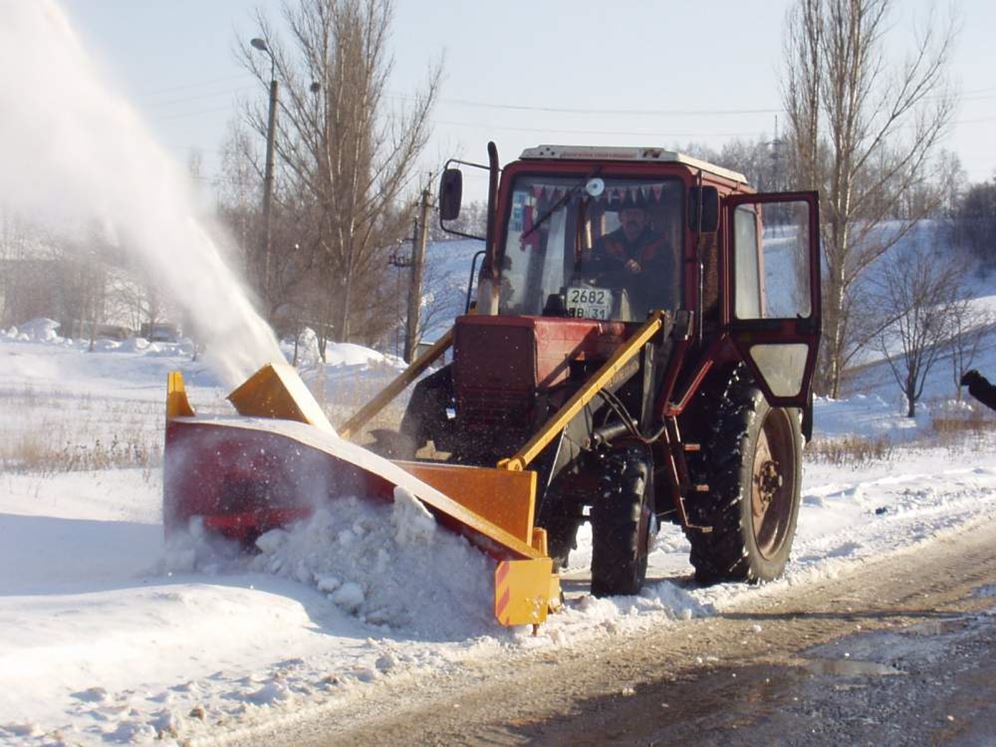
[[724, 192, 820, 412]]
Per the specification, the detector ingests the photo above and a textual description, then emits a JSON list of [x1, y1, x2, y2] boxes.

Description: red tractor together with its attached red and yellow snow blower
[[163, 144, 820, 626]]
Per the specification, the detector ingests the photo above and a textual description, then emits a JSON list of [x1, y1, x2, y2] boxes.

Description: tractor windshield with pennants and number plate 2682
[[499, 176, 683, 322]]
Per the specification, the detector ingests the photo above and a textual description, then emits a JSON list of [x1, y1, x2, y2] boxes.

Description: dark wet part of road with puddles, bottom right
[[512, 599, 996, 747]]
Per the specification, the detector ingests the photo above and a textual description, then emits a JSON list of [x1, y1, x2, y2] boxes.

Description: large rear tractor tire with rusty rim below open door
[[686, 367, 802, 584]]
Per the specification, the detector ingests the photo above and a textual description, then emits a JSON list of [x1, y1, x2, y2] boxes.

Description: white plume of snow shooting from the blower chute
[[0, 0, 282, 387]]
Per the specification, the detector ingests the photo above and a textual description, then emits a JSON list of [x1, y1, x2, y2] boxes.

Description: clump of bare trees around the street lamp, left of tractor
[[220, 0, 441, 352]]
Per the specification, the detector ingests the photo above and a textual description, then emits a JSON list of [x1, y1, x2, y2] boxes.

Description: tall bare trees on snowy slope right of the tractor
[[782, 0, 993, 417]]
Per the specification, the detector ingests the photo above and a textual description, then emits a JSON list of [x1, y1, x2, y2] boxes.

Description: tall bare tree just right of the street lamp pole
[[240, 0, 441, 354]]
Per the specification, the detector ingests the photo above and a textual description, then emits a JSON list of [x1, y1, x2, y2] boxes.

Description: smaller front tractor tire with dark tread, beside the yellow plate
[[591, 449, 655, 597]]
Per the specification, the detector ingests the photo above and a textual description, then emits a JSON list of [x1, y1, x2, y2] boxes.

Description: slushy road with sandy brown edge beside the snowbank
[[290, 523, 996, 745]]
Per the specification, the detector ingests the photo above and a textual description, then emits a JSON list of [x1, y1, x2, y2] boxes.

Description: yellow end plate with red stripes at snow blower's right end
[[495, 558, 560, 625]]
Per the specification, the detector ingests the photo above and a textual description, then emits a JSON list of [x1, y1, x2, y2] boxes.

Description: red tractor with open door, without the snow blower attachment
[[372, 144, 820, 595]]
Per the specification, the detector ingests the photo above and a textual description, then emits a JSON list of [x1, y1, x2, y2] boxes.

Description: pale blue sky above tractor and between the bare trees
[[62, 0, 996, 200]]
